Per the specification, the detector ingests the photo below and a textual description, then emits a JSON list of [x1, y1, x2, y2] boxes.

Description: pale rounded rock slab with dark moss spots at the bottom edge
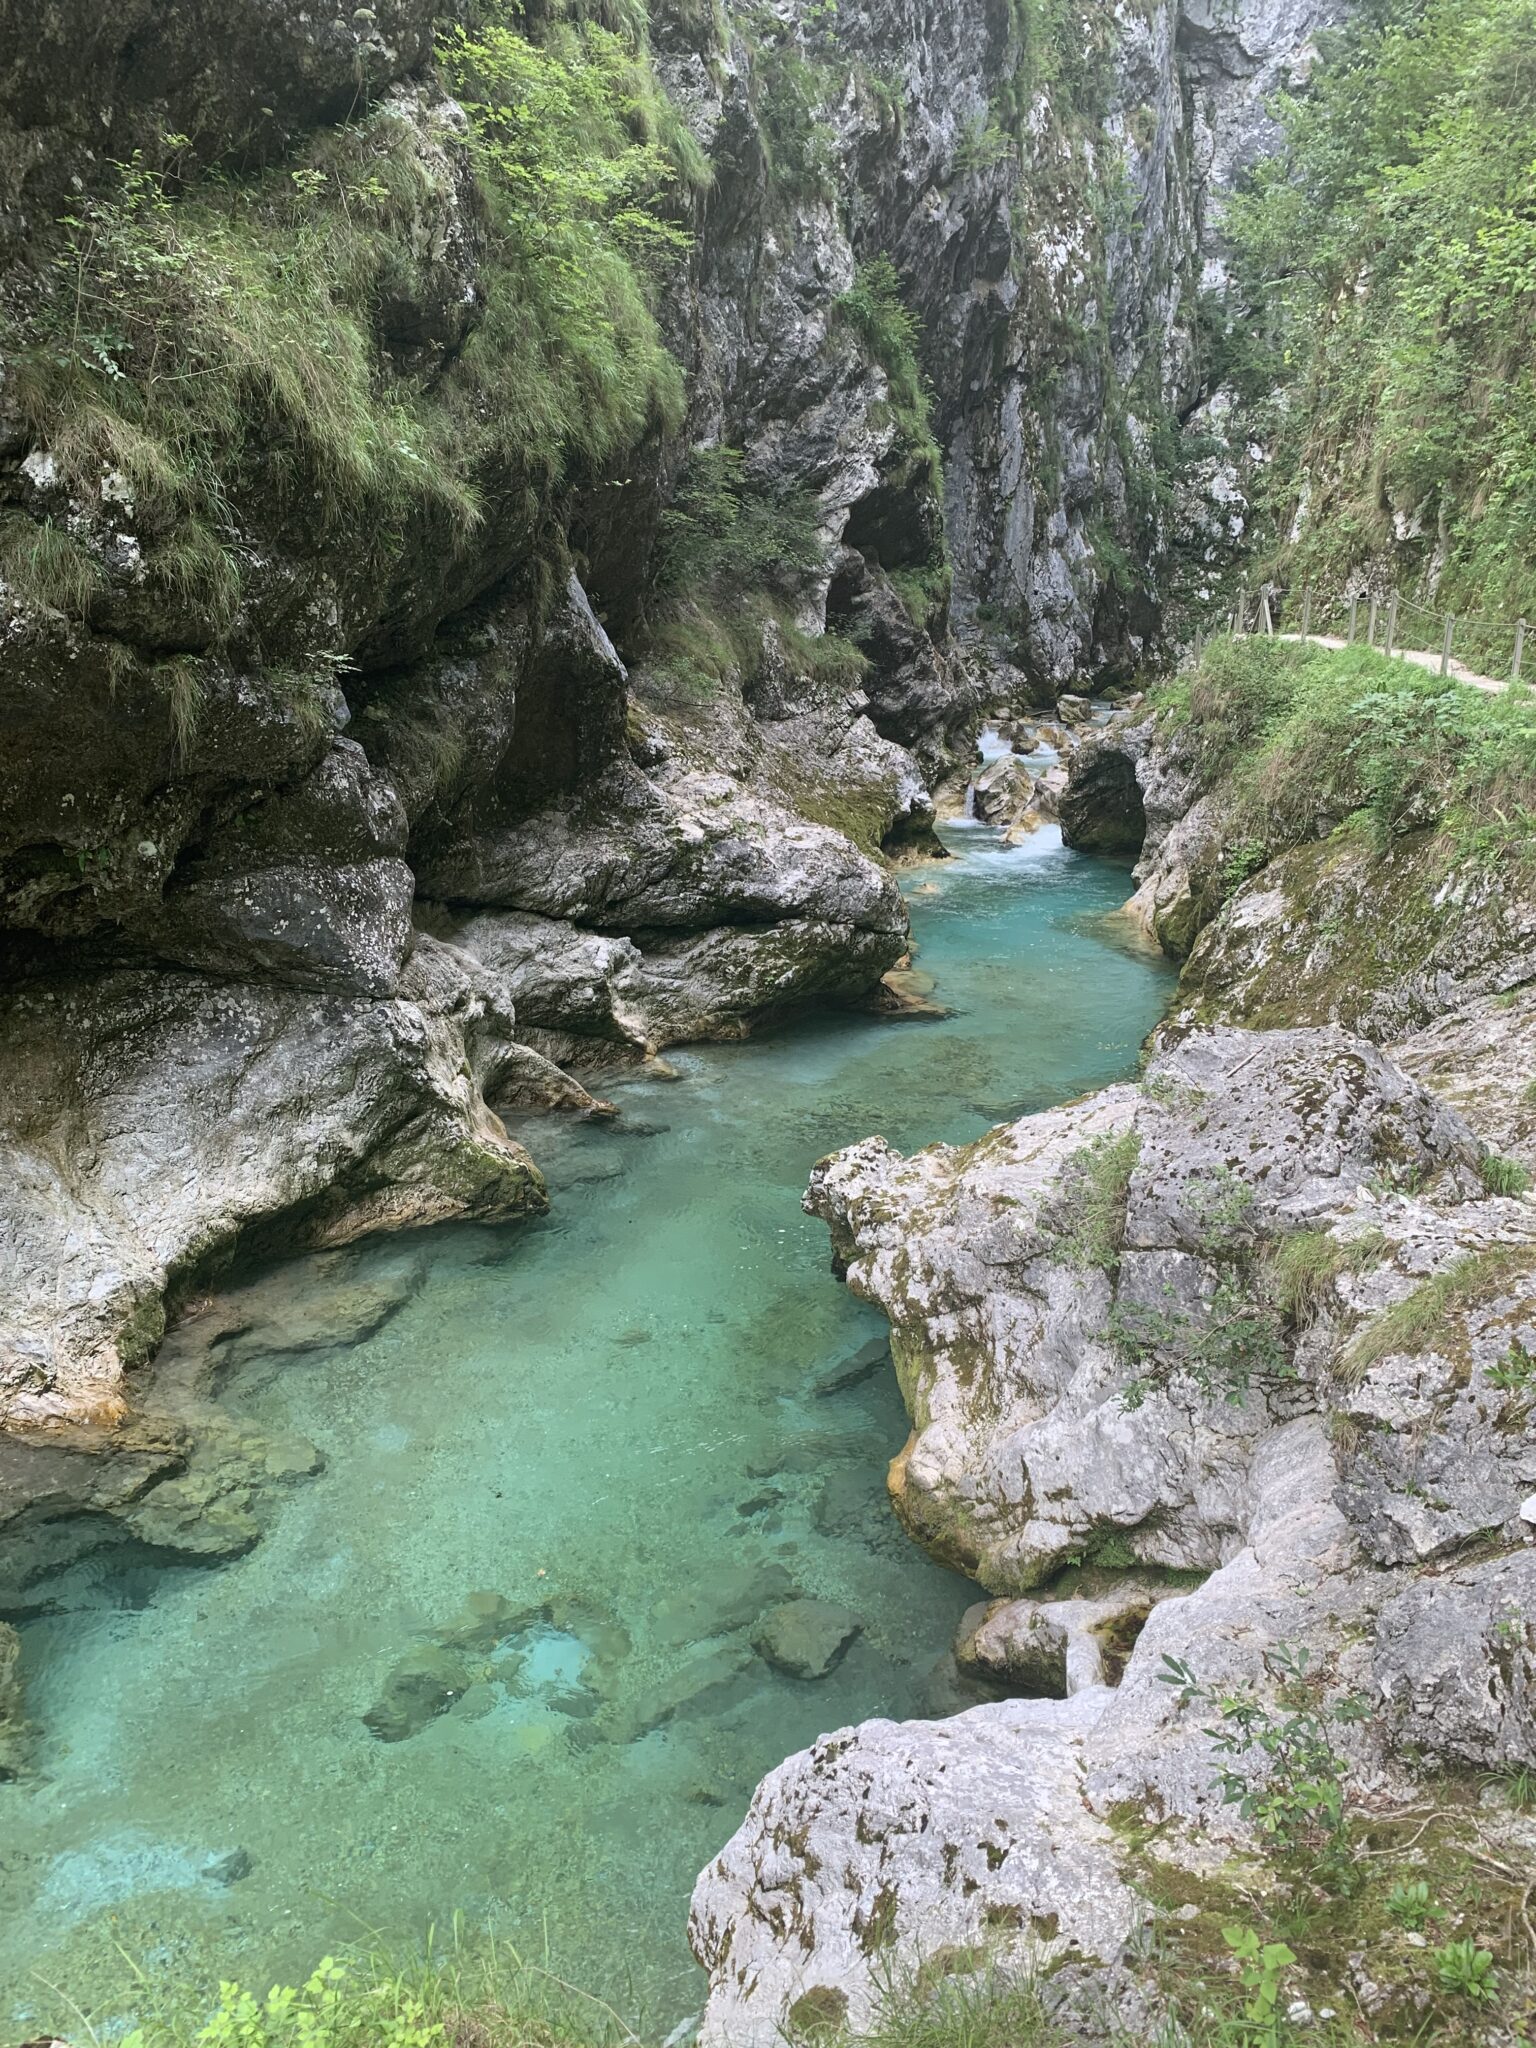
[[688, 1696, 1141, 2048]]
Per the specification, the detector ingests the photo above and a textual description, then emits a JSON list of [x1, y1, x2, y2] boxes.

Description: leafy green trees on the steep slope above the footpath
[[1227, 0, 1536, 630]]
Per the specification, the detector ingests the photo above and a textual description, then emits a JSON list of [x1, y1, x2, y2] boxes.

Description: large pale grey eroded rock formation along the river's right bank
[[692, 1028, 1536, 2048]]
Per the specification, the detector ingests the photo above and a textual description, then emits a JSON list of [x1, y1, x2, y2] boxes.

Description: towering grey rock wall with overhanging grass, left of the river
[[0, 0, 1343, 1458]]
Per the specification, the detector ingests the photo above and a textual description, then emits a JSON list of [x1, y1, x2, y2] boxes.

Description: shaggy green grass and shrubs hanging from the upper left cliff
[[0, 0, 702, 653]]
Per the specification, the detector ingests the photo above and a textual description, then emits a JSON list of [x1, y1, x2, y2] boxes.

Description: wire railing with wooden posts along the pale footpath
[[1194, 584, 1526, 690]]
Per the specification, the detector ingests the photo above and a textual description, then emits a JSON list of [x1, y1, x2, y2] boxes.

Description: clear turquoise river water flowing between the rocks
[[0, 825, 1167, 2025]]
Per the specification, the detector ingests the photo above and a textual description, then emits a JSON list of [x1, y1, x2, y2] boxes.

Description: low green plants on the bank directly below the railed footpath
[[1155, 639, 1536, 860]]
